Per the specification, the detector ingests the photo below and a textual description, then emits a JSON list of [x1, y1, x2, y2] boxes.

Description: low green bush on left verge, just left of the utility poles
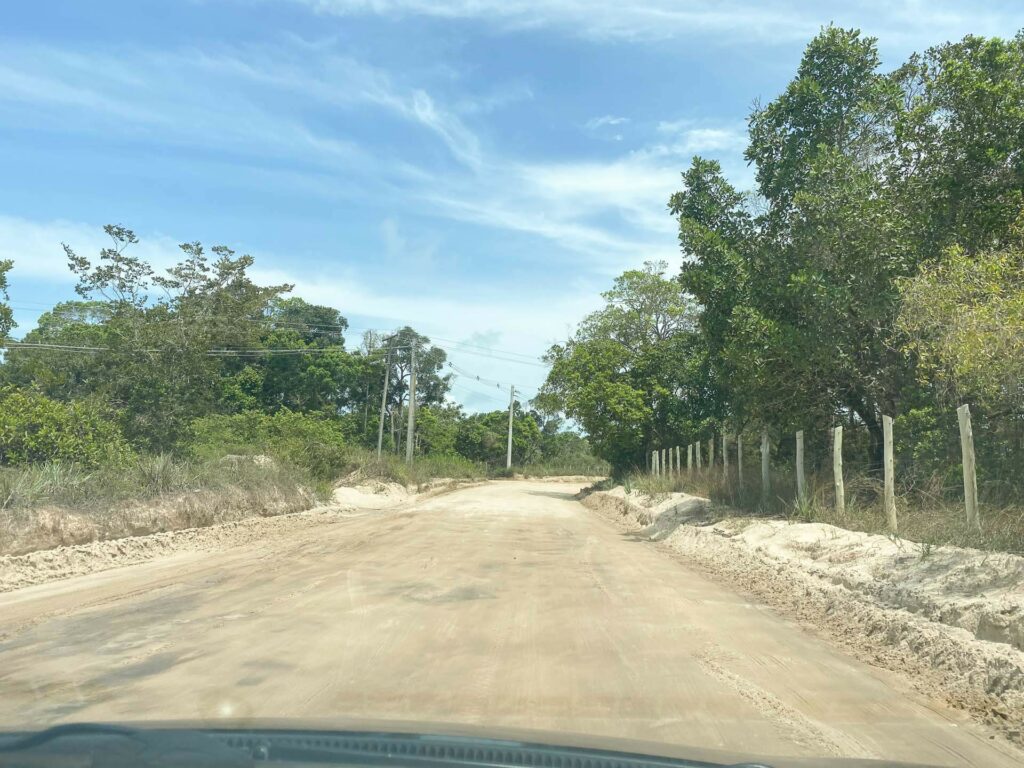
[[191, 409, 346, 479]]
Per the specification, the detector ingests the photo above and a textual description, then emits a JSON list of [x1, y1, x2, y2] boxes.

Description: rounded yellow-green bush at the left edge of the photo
[[0, 387, 131, 467]]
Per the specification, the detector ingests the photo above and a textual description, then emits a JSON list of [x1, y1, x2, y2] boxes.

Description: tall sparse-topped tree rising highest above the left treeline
[[55, 225, 291, 451]]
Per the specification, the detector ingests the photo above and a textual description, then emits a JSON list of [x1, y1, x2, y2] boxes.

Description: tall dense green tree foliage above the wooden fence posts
[[670, 27, 1024, 475]]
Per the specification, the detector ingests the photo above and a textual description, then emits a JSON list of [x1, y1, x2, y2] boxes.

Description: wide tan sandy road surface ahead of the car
[[0, 481, 1020, 767]]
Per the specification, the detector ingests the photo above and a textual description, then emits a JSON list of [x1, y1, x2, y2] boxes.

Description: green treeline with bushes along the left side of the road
[[0, 225, 603, 478]]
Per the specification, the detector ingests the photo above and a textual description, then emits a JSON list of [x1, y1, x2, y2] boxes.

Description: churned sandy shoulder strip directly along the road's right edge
[[582, 488, 1024, 745]]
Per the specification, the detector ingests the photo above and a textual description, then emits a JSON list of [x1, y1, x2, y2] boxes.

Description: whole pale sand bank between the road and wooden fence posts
[[583, 487, 1024, 742]]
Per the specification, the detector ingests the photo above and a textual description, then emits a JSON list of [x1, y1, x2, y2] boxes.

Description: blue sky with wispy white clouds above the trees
[[6, 0, 1024, 410]]
